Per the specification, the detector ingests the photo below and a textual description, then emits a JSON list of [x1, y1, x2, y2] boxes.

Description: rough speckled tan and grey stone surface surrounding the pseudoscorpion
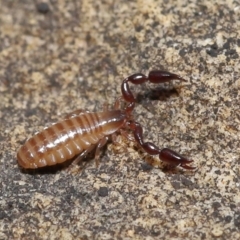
[[0, 0, 240, 239]]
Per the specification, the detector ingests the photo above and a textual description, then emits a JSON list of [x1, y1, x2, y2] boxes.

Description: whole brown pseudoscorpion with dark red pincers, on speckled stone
[[17, 70, 195, 170]]
